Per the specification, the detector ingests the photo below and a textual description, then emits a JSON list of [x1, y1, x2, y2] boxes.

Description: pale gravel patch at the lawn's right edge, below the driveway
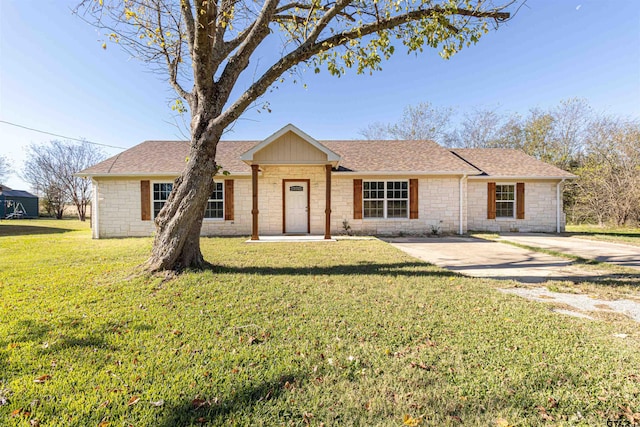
[[500, 288, 640, 322]]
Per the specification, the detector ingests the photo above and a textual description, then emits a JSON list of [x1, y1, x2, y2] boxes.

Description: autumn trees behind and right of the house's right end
[[360, 98, 640, 226]]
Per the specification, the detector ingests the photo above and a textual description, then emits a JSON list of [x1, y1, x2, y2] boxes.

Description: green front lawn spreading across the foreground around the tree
[[0, 220, 640, 427]]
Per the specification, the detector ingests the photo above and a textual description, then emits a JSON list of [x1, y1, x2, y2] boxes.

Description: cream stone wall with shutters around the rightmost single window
[[467, 179, 564, 233]]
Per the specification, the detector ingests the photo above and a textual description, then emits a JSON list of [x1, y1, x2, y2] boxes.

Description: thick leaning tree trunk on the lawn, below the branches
[[146, 123, 222, 272]]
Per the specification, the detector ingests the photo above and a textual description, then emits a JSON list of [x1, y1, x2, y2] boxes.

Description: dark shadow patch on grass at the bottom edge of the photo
[[157, 373, 305, 427]]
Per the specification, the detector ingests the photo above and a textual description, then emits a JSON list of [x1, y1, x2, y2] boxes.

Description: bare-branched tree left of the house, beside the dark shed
[[23, 141, 105, 221]]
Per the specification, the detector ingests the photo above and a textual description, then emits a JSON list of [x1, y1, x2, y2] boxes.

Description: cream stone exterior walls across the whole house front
[[91, 172, 564, 238]]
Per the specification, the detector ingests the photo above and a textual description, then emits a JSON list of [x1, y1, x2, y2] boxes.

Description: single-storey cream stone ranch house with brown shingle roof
[[78, 124, 574, 240]]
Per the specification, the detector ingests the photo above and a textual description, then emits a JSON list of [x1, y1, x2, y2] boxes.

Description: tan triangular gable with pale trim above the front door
[[240, 124, 340, 166]]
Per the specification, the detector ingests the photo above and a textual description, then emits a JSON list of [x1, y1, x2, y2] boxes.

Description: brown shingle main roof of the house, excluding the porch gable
[[80, 141, 573, 178]]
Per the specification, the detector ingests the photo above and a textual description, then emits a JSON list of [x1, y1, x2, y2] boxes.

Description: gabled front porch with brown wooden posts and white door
[[240, 125, 340, 241]]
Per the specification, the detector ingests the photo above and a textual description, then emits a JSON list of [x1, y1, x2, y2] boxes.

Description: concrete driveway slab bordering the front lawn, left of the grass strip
[[385, 237, 606, 283]]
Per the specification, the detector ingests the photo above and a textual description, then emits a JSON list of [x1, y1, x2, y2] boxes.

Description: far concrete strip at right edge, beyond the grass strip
[[500, 233, 640, 270]]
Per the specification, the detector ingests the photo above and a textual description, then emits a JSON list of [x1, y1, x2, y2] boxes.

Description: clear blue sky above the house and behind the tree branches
[[0, 0, 640, 189]]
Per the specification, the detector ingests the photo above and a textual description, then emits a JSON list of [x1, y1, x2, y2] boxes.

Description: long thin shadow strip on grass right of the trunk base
[[205, 262, 459, 277]]
